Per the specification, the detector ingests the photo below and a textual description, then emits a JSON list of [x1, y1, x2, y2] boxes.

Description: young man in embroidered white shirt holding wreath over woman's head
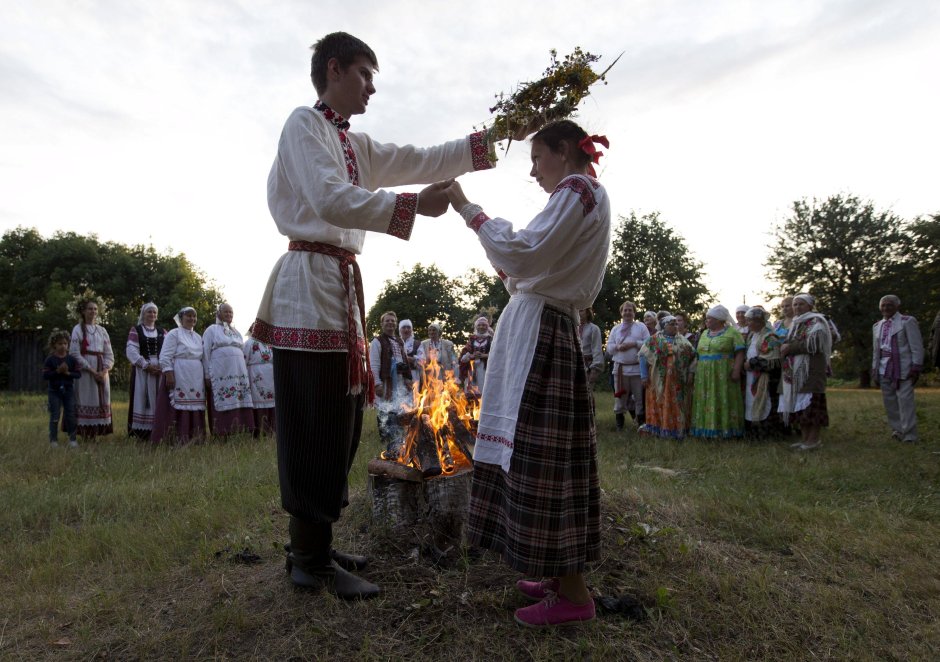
[[251, 32, 500, 600]]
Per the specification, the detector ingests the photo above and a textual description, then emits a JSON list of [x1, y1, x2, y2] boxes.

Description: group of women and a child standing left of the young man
[[43, 300, 275, 448]]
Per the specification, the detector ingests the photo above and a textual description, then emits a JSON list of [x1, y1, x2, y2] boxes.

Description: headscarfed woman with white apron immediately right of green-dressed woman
[[744, 307, 781, 437]]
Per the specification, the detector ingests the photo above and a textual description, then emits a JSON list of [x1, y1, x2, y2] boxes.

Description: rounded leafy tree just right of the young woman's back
[[594, 211, 711, 328]]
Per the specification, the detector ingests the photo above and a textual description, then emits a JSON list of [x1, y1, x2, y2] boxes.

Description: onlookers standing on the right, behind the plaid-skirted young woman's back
[[581, 293, 940, 451]]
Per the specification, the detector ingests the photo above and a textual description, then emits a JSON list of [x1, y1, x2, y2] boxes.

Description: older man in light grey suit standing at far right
[[871, 294, 924, 442]]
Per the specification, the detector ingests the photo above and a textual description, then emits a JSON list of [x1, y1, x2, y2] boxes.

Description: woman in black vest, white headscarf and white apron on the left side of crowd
[[125, 301, 166, 440]]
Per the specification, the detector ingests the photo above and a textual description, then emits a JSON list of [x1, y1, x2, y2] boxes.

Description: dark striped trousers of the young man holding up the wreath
[[274, 349, 364, 523]]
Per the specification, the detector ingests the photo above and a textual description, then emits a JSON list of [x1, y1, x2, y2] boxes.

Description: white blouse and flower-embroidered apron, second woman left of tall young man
[[202, 324, 252, 412]]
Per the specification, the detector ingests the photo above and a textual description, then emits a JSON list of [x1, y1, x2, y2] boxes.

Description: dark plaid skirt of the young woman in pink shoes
[[467, 305, 600, 577]]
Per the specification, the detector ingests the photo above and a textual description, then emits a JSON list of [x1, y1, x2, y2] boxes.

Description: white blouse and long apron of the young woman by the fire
[[471, 175, 610, 471]]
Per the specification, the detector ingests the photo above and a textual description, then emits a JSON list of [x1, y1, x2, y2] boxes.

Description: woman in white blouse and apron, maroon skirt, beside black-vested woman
[[150, 307, 206, 444]]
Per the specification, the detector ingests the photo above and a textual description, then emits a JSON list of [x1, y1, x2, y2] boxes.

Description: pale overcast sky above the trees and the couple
[[0, 0, 940, 332]]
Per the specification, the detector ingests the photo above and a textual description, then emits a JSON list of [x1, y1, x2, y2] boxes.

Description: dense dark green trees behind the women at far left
[[0, 228, 222, 383]]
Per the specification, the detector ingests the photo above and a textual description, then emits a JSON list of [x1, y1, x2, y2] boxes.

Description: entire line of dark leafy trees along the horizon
[[0, 194, 940, 387]]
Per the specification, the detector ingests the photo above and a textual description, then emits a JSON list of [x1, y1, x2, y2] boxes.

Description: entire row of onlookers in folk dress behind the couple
[[43, 294, 940, 450]]
